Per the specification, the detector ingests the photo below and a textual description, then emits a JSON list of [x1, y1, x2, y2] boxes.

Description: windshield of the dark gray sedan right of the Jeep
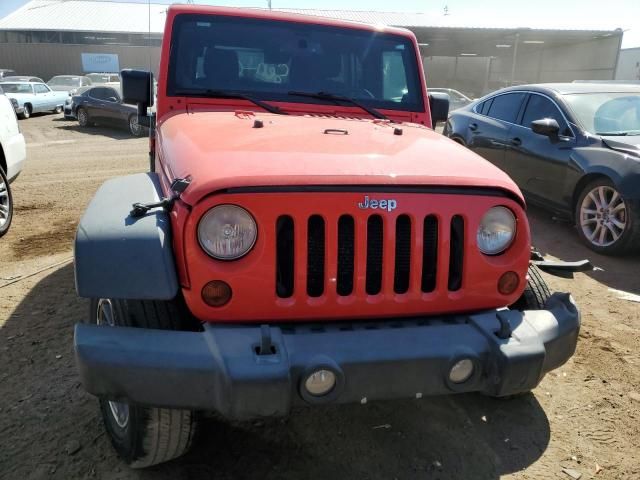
[[565, 92, 640, 135]]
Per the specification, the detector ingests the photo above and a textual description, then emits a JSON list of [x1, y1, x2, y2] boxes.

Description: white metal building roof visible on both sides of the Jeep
[[0, 0, 615, 34]]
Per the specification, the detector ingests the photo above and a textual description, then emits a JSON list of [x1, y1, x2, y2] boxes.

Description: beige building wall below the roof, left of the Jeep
[[0, 43, 160, 81]]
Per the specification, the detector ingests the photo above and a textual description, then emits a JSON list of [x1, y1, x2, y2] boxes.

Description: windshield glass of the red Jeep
[[167, 15, 424, 111]]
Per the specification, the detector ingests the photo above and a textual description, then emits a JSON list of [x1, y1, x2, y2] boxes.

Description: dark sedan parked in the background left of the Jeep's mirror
[[70, 86, 145, 137]]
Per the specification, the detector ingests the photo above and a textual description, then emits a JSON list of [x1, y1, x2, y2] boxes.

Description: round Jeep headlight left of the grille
[[198, 204, 258, 260]]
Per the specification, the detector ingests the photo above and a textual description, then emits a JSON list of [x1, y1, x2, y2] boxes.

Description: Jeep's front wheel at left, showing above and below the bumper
[[91, 298, 197, 468]]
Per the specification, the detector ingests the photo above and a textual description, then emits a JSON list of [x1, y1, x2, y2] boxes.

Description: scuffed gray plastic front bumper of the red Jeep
[[75, 294, 580, 419]]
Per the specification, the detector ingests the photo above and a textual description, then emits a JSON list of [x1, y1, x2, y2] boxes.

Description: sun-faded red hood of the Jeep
[[158, 111, 522, 205]]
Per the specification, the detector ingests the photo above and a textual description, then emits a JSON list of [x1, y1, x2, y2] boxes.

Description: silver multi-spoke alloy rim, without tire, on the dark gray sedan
[[580, 185, 627, 247]]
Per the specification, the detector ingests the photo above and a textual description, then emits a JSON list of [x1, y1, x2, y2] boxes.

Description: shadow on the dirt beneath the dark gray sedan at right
[[527, 207, 640, 294]]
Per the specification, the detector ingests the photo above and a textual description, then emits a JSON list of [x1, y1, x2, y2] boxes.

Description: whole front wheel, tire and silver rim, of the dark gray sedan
[[575, 178, 640, 255]]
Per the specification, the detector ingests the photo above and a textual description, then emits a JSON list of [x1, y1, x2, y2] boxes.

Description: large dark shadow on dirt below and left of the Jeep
[[0, 265, 550, 480]]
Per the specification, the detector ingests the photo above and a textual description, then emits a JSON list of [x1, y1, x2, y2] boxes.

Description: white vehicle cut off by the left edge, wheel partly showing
[[0, 86, 27, 237]]
